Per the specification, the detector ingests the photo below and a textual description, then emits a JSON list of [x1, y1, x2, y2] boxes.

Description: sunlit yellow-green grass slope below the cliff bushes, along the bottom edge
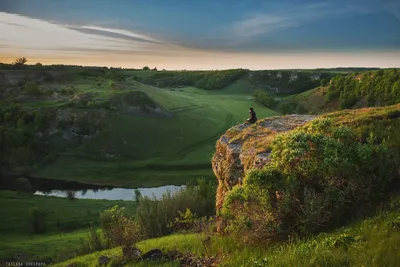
[[54, 211, 400, 266]]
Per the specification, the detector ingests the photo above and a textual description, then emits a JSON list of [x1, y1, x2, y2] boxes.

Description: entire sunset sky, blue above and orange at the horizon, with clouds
[[0, 0, 400, 69]]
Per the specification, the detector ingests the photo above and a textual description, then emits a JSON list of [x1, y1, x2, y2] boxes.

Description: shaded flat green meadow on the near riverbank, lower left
[[0, 191, 136, 260]]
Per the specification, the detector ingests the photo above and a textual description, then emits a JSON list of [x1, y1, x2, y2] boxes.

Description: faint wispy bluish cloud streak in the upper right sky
[[232, 3, 346, 39]]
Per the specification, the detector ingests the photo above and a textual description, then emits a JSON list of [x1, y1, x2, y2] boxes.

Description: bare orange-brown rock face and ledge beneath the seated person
[[212, 115, 315, 231]]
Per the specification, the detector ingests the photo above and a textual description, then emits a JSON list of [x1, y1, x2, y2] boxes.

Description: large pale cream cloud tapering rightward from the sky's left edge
[[0, 12, 188, 58]]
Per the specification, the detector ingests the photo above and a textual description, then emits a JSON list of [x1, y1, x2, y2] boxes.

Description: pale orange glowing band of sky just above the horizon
[[0, 51, 400, 70]]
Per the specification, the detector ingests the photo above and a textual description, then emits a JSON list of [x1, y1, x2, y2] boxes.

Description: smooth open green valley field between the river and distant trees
[[29, 75, 278, 187]]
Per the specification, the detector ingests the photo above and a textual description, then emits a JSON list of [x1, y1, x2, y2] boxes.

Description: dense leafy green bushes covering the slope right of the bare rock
[[222, 105, 400, 242]]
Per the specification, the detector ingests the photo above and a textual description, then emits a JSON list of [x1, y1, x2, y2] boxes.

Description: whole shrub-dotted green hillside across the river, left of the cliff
[[0, 68, 278, 187]]
